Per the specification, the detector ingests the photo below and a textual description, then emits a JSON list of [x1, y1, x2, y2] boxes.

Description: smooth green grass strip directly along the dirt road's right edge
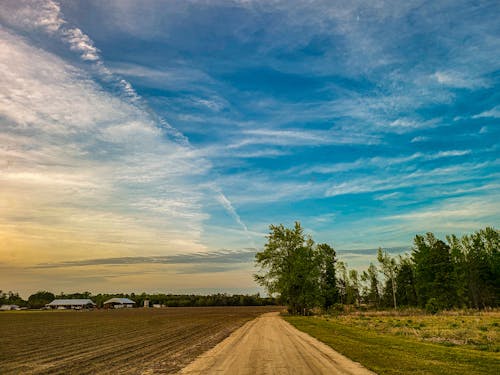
[[285, 316, 500, 375]]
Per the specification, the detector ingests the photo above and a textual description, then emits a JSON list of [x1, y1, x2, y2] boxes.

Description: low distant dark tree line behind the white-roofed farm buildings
[[0, 290, 276, 309]]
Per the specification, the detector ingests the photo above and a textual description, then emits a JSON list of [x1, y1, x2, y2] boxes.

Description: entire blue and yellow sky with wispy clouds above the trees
[[0, 0, 500, 297]]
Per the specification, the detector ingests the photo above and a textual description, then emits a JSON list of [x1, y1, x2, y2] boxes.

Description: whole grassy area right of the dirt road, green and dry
[[285, 311, 500, 375]]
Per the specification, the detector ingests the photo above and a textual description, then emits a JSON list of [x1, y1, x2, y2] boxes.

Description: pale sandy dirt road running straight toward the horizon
[[181, 313, 374, 375]]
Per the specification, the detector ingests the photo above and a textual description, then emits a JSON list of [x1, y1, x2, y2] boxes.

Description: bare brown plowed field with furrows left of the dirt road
[[0, 307, 276, 374]]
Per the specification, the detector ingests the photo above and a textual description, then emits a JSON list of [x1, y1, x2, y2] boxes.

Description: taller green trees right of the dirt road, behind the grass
[[255, 222, 500, 314]]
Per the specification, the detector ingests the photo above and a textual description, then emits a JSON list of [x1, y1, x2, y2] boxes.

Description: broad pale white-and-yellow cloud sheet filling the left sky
[[0, 27, 210, 257]]
